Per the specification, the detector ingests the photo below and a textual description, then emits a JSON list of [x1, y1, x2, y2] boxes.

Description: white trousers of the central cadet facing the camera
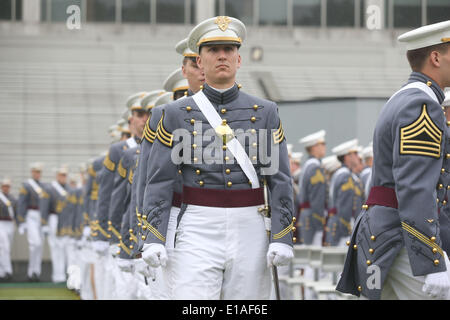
[[172, 205, 270, 300]]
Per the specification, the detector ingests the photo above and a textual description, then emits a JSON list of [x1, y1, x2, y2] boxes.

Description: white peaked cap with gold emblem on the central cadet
[[188, 16, 247, 53]]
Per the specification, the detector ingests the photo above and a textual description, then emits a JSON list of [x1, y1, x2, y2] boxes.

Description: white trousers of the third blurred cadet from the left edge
[[47, 214, 66, 282]]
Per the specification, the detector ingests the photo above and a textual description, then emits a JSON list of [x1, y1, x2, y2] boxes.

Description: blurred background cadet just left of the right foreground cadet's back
[[325, 139, 359, 246]]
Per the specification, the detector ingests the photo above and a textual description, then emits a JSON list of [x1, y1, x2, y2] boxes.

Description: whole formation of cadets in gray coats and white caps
[[0, 16, 450, 300]]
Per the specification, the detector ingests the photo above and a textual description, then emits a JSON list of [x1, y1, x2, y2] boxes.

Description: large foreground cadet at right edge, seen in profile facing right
[[337, 20, 450, 300]]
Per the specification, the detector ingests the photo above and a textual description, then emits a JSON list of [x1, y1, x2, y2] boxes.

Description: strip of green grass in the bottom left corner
[[0, 282, 80, 300]]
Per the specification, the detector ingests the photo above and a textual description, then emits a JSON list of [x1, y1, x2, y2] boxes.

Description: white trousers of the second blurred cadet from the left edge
[[25, 209, 43, 277]]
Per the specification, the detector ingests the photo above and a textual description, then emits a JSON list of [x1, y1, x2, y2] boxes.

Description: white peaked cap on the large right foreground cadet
[[397, 20, 450, 50]]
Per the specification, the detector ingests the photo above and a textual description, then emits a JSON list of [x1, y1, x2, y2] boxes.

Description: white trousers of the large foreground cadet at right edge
[[381, 247, 450, 300]]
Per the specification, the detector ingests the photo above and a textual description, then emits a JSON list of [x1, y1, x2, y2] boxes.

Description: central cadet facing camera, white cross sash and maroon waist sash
[[142, 17, 293, 299]]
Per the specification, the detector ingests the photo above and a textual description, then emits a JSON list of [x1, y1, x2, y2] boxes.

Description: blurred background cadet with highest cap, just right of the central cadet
[[298, 130, 327, 246]]
